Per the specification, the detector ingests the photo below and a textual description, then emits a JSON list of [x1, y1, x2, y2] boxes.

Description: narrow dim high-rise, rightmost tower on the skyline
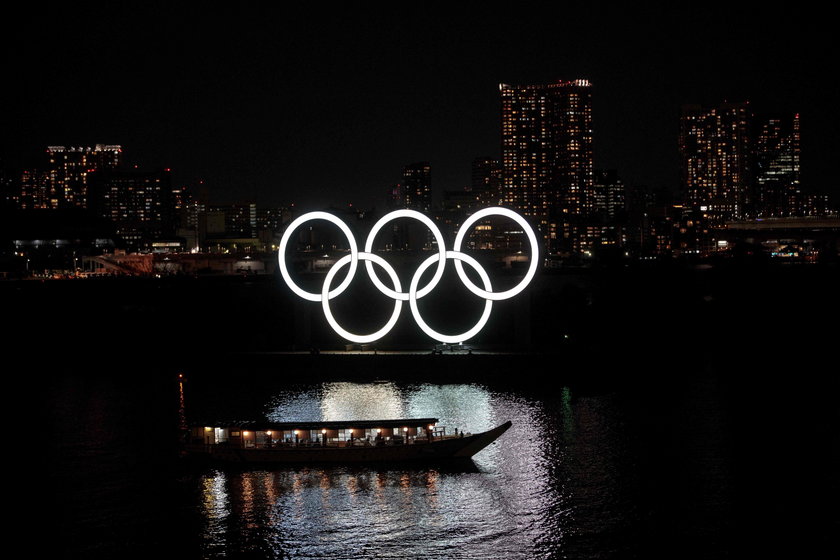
[[753, 113, 805, 217]]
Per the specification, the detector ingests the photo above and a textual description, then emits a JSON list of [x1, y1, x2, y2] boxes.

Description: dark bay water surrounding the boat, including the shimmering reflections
[[19, 268, 840, 559]]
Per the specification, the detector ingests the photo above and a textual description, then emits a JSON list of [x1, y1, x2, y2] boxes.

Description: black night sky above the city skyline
[[0, 2, 840, 207]]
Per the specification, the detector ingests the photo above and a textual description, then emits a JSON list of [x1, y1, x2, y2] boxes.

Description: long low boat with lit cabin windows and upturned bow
[[184, 418, 511, 463]]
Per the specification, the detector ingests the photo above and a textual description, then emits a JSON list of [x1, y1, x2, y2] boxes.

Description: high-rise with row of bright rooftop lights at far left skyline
[[47, 144, 122, 208]]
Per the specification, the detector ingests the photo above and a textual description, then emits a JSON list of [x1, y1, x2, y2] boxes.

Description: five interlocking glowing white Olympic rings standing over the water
[[278, 207, 539, 344]]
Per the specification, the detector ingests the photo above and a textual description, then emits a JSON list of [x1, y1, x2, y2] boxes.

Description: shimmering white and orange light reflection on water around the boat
[[203, 383, 565, 558]]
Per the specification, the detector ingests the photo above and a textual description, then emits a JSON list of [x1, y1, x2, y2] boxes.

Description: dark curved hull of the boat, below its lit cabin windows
[[187, 421, 511, 464]]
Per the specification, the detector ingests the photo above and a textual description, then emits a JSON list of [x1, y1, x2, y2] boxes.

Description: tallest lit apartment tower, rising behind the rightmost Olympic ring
[[499, 80, 594, 228]]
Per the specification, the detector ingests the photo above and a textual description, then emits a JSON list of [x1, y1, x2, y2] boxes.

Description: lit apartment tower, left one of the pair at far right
[[679, 103, 754, 224]]
